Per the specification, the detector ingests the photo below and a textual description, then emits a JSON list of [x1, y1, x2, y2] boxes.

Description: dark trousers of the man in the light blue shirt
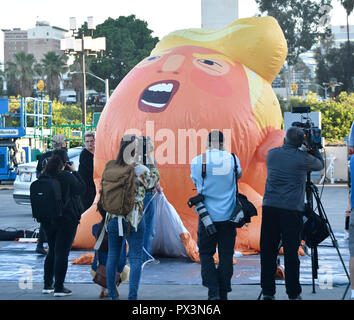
[[197, 219, 236, 299]]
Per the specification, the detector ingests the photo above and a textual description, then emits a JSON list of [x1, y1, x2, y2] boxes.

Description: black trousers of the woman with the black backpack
[[43, 221, 77, 291]]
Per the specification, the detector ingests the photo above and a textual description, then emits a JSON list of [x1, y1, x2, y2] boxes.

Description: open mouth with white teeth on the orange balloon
[[139, 80, 179, 112]]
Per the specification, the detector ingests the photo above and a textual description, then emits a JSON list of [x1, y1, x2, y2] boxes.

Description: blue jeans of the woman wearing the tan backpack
[[106, 218, 145, 300]]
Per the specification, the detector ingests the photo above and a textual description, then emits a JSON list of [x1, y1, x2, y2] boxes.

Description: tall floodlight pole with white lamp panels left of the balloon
[[60, 16, 106, 126]]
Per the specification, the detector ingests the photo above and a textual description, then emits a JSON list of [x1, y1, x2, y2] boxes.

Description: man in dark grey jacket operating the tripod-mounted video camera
[[260, 126, 324, 300]]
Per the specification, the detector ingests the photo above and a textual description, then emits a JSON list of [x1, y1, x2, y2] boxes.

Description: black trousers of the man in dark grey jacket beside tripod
[[260, 206, 303, 298]]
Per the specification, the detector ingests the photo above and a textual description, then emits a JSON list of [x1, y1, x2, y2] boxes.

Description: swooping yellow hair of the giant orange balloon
[[151, 17, 287, 130]]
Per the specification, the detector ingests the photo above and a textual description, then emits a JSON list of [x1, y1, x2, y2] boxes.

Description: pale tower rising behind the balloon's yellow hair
[[202, 0, 238, 29]]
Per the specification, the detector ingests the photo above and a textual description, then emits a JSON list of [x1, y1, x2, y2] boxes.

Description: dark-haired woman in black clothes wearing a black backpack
[[39, 149, 86, 297]]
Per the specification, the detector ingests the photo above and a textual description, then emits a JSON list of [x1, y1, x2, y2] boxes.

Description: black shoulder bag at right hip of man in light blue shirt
[[229, 153, 257, 228]]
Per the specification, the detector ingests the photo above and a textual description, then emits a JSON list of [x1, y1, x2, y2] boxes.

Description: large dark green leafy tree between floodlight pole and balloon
[[83, 15, 158, 92]]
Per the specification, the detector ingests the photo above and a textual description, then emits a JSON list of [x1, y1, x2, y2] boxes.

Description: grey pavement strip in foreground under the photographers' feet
[[0, 282, 349, 301]]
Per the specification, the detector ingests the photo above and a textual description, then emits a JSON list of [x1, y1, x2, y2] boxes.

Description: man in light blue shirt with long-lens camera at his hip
[[188, 131, 242, 300]]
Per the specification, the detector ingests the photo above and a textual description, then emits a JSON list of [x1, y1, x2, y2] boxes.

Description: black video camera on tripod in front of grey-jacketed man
[[291, 107, 323, 151]]
